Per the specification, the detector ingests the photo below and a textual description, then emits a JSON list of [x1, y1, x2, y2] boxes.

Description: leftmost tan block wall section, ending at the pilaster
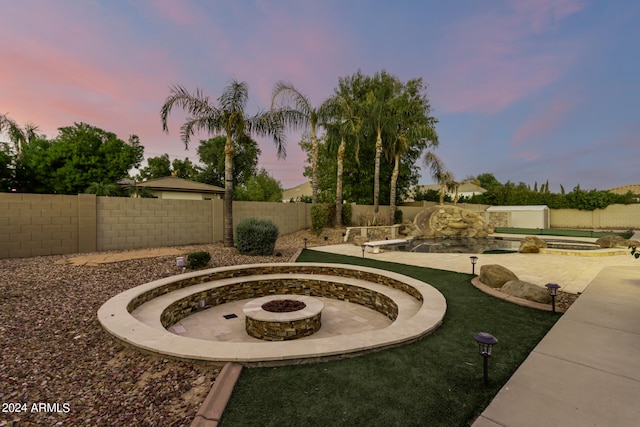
[[0, 193, 81, 258]]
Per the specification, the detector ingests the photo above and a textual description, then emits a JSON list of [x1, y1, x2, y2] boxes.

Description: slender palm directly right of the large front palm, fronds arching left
[[271, 80, 322, 203]]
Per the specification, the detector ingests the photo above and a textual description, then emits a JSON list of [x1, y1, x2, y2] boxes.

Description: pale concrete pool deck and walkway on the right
[[314, 233, 640, 427]]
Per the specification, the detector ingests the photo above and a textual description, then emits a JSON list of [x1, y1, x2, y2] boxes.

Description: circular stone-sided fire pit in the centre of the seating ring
[[243, 295, 324, 341]]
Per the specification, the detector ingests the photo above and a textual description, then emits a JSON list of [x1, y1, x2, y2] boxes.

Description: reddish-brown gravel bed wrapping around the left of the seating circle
[[0, 229, 343, 427]]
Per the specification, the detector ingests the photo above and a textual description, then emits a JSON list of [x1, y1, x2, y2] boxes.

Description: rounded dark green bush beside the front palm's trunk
[[236, 218, 279, 255]]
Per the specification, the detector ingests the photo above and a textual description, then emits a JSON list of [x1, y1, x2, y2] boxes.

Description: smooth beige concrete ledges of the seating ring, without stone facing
[[98, 263, 446, 366]]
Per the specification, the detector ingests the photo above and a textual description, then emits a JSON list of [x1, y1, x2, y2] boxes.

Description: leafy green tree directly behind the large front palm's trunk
[[198, 135, 261, 188]]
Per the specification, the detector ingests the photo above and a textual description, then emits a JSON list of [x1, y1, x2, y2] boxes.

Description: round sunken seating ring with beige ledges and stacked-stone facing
[[98, 263, 446, 366]]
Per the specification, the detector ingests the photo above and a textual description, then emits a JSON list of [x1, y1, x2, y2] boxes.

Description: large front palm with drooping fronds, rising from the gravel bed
[[160, 79, 286, 247]]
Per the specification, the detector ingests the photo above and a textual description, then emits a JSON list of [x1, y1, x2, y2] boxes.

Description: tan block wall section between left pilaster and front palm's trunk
[[97, 197, 214, 251]]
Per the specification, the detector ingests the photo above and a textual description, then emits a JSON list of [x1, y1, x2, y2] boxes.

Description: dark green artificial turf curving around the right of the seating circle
[[221, 250, 560, 427]]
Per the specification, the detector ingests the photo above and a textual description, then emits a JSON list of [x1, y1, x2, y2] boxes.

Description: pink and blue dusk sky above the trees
[[0, 0, 640, 191]]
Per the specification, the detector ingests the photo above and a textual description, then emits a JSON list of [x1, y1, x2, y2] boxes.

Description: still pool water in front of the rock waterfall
[[384, 237, 599, 254]]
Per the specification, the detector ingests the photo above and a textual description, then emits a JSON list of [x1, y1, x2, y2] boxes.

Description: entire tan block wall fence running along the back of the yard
[[0, 193, 640, 259]]
